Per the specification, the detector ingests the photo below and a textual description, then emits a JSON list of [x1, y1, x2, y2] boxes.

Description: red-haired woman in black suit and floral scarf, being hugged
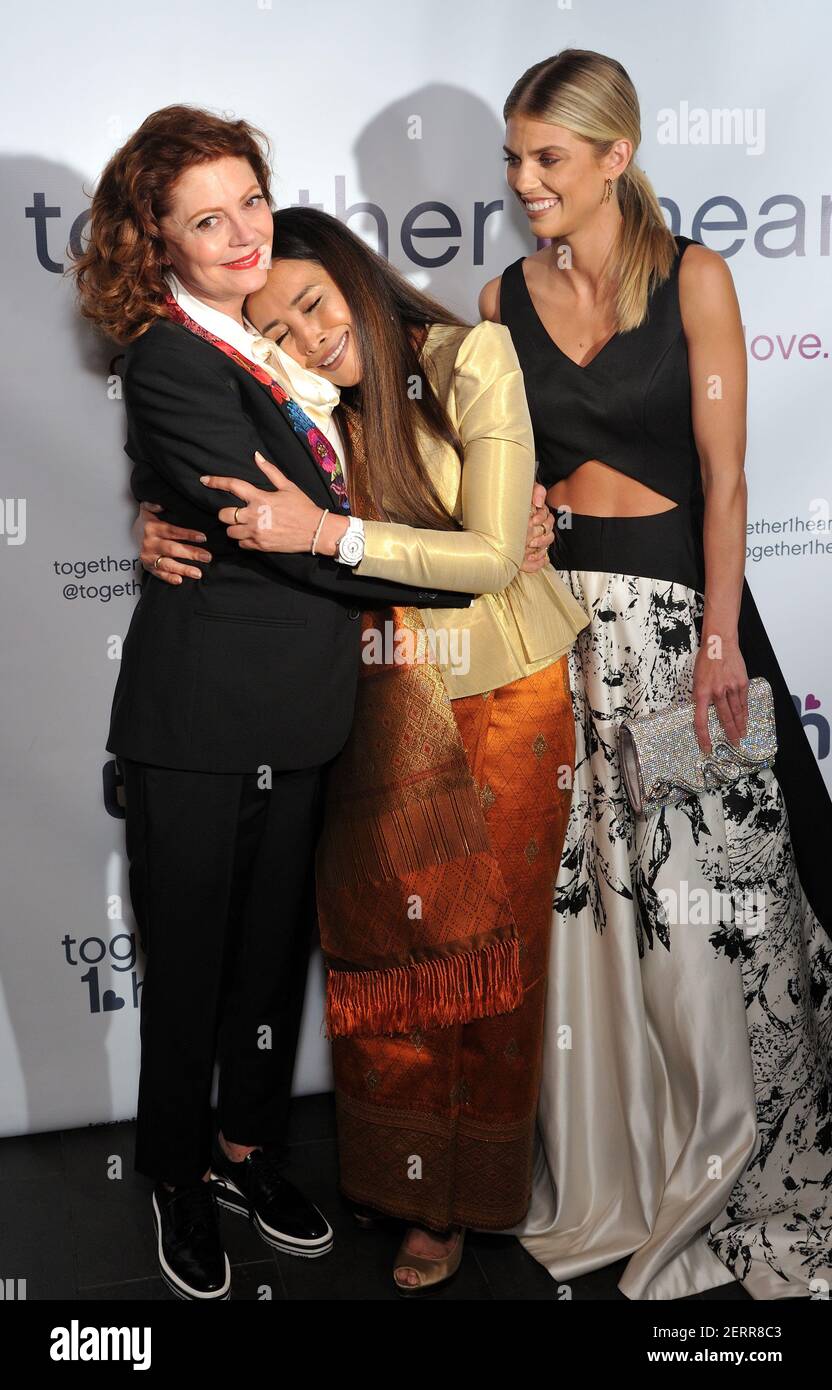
[[75, 106, 486, 1300]]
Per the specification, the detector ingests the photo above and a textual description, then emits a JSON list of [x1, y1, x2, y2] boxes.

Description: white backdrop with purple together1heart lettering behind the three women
[[0, 0, 832, 1134]]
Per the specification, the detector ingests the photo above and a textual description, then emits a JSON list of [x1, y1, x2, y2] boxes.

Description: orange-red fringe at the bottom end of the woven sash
[[325, 937, 524, 1041]]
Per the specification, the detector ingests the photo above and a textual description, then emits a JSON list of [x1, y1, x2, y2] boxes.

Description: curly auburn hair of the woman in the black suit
[[69, 106, 271, 343]]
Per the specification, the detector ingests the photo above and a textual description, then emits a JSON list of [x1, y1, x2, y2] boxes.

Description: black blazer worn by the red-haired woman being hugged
[[107, 320, 471, 773]]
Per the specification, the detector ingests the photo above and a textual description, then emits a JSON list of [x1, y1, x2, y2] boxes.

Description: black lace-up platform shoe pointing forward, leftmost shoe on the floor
[[153, 1180, 231, 1300]]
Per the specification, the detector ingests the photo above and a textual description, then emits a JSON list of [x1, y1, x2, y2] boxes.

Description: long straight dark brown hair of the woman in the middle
[[263, 207, 471, 531]]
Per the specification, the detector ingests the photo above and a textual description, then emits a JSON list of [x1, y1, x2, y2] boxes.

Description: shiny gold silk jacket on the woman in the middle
[[356, 321, 589, 699]]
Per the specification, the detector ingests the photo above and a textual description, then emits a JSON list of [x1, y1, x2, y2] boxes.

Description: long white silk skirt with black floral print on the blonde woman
[[514, 509, 832, 1300]]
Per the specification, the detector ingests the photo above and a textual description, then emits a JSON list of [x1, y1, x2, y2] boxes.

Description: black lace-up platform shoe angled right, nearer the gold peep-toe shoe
[[211, 1136, 333, 1259]]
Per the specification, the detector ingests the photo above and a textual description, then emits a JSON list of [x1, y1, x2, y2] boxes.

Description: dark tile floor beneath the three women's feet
[[0, 1094, 747, 1302]]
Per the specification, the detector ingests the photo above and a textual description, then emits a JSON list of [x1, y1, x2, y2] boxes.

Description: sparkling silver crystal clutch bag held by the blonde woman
[[618, 676, 776, 816]]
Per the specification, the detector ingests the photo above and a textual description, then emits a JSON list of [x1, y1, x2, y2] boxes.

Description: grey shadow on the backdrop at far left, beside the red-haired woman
[[0, 153, 135, 1133]]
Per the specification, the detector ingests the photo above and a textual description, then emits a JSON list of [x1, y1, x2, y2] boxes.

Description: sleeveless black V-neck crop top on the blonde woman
[[500, 236, 701, 505]]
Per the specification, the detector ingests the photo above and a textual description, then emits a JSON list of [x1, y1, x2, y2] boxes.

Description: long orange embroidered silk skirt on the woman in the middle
[[332, 656, 575, 1230]]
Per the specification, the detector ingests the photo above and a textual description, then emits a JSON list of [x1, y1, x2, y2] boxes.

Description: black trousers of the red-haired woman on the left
[[118, 758, 324, 1184]]
